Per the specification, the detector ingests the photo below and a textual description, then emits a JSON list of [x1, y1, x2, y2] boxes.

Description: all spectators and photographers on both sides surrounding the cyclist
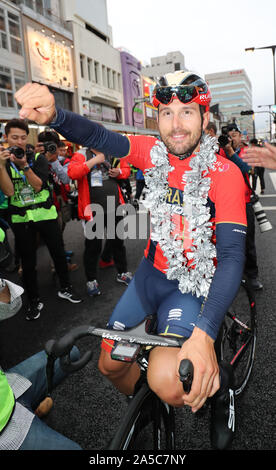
[[0, 114, 265, 450]]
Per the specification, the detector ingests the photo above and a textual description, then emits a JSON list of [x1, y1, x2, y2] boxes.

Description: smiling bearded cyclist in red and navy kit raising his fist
[[15, 71, 246, 449]]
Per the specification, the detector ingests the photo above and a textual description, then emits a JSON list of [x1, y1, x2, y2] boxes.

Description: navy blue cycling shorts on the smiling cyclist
[[102, 258, 204, 350]]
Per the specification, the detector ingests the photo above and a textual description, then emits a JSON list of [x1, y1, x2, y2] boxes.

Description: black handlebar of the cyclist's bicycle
[[45, 320, 193, 393]]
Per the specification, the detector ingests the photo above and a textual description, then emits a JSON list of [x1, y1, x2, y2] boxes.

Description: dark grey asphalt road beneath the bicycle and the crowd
[[0, 171, 276, 450]]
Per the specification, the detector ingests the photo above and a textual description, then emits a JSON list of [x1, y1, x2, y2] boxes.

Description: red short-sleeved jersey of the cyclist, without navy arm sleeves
[[123, 136, 246, 272]]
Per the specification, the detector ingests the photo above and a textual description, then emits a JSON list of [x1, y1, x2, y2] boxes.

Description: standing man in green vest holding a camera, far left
[[0, 119, 81, 320]]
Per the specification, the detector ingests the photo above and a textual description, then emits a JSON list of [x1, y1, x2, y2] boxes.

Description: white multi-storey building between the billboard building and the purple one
[[60, 0, 124, 124]]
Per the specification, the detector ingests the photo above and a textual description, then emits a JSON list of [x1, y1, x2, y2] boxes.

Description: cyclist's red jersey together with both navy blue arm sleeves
[[52, 109, 247, 339]]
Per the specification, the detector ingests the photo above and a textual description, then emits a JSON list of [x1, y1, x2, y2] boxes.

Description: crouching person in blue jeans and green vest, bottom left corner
[[0, 266, 81, 451]]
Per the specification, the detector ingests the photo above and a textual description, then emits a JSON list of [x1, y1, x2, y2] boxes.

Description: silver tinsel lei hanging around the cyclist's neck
[[144, 135, 218, 297]]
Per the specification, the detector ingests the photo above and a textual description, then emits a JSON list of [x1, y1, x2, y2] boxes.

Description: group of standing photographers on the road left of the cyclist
[[0, 119, 141, 320]]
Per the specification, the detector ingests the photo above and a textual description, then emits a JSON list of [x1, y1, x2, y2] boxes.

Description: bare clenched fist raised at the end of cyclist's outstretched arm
[[14, 83, 56, 125]]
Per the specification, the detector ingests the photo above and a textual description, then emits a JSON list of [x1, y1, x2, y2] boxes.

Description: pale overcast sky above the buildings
[[107, 0, 276, 135]]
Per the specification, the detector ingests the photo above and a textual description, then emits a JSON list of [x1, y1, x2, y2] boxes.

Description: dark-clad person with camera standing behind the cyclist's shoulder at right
[[218, 123, 263, 290]]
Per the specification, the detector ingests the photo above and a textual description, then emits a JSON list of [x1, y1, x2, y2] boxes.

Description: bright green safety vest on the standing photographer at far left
[[9, 154, 57, 224]]
